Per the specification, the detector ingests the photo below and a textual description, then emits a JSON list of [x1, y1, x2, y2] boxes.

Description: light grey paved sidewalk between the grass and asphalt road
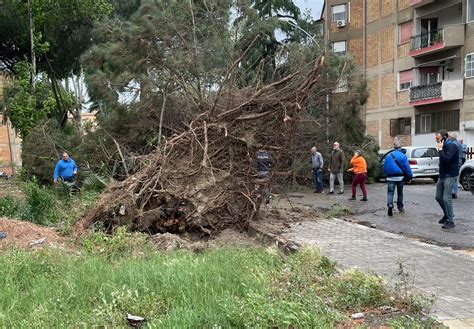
[[284, 219, 474, 328]]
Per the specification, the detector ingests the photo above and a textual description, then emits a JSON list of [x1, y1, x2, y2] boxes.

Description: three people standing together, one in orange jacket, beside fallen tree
[[311, 142, 368, 201]]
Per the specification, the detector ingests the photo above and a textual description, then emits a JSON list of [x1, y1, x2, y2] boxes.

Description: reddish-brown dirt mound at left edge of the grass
[[0, 218, 65, 250]]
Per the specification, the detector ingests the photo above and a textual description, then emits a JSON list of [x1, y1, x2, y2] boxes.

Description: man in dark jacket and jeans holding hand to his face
[[435, 132, 459, 229]]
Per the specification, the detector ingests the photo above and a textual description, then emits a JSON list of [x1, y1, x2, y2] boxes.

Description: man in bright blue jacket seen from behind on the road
[[383, 139, 413, 216]]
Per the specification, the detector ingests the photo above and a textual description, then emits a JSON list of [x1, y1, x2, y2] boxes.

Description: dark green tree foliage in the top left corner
[[0, 0, 113, 78]]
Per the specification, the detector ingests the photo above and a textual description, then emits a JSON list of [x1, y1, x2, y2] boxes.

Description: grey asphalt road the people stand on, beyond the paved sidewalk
[[290, 180, 474, 249]]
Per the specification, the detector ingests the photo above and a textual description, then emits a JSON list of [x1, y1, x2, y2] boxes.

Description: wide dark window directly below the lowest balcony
[[415, 110, 459, 134]]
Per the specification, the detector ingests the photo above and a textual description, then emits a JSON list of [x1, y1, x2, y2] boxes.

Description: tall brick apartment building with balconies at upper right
[[322, 0, 474, 149]]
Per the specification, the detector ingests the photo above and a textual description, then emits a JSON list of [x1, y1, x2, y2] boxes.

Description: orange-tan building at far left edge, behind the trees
[[0, 66, 21, 175]]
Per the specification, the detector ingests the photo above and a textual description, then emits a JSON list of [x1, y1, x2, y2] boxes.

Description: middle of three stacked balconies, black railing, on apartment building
[[409, 24, 464, 57]]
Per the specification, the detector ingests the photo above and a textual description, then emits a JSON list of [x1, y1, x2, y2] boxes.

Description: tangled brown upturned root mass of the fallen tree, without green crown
[[82, 56, 324, 234]]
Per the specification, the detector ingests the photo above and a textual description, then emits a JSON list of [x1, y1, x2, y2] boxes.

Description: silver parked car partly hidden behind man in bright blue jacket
[[379, 146, 439, 182]]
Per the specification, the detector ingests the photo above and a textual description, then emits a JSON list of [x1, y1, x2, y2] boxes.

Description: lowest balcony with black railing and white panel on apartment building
[[410, 79, 464, 106]]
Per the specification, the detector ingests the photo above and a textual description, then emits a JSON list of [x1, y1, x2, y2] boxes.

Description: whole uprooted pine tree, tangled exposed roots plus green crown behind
[[73, 1, 370, 234]]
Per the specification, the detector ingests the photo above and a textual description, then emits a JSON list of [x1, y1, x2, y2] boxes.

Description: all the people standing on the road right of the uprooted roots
[[311, 131, 467, 229]]
